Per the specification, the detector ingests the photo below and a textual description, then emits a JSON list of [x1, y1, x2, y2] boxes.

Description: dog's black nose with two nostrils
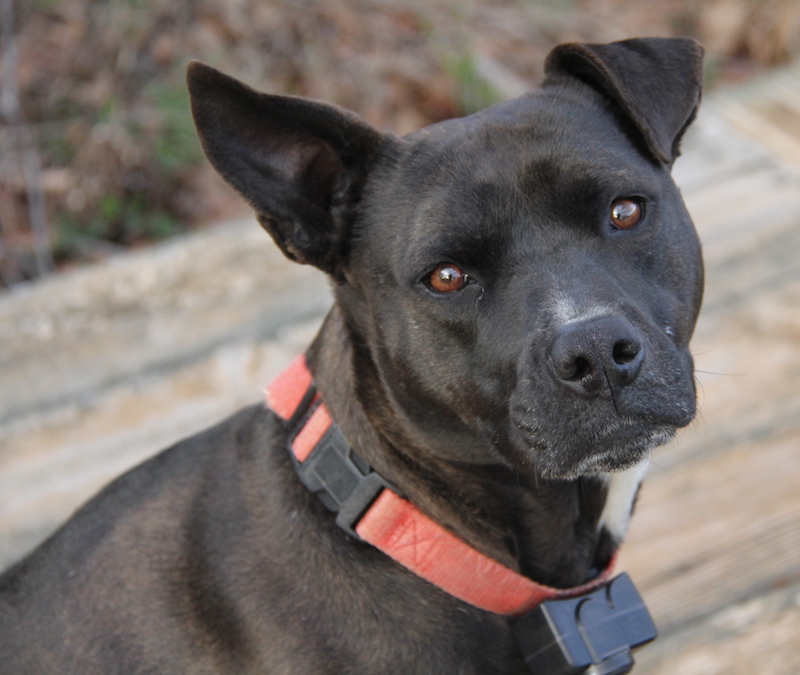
[[549, 317, 644, 395]]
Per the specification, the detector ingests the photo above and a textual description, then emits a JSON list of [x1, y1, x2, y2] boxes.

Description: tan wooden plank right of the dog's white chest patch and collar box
[[620, 433, 800, 632]]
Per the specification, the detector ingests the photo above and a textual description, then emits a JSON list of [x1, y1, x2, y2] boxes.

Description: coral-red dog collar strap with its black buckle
[[266, 355, 614, 616]]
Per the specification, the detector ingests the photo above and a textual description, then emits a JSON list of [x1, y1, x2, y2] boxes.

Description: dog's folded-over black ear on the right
[[545, 38, 703, 166]]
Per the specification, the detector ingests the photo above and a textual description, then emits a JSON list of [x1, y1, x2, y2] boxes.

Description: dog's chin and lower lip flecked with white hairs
[[514, 419, 676, 480]]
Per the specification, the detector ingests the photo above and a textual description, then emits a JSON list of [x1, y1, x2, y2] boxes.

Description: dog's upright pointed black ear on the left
[[187, 61, 387, 275]]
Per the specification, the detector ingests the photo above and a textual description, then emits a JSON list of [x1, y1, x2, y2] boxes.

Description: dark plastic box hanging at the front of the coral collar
[[512, 573, 657, 675]]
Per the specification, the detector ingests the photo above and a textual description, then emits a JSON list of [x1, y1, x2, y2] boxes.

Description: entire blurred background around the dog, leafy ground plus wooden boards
[[0, 0, 800, 675]]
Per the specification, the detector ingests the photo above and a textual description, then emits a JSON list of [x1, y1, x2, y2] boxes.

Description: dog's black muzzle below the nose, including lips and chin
[[505, 339, 696, 480]]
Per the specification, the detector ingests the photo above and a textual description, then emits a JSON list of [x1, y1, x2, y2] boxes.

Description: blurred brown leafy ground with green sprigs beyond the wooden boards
[[0, 0, 800, 286]]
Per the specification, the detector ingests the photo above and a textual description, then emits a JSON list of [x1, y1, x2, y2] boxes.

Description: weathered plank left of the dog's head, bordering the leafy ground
[[0, 217, 331, 426]]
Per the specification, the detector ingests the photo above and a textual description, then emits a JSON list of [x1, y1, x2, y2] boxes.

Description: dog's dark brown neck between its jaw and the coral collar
[[308, 306, 638, 588]]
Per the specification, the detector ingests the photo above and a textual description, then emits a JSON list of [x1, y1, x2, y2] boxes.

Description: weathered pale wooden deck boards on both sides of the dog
[[0, 62, 800, 675]]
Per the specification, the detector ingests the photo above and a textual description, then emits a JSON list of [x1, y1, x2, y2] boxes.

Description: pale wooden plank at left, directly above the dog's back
[[0, 320, 319, 570]]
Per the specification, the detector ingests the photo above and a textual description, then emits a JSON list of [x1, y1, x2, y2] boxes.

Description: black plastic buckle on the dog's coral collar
[[288, 406, 397, 541]]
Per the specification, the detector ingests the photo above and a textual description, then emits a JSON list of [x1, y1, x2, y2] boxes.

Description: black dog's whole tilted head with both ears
[[189, 39, 702, 478]]
